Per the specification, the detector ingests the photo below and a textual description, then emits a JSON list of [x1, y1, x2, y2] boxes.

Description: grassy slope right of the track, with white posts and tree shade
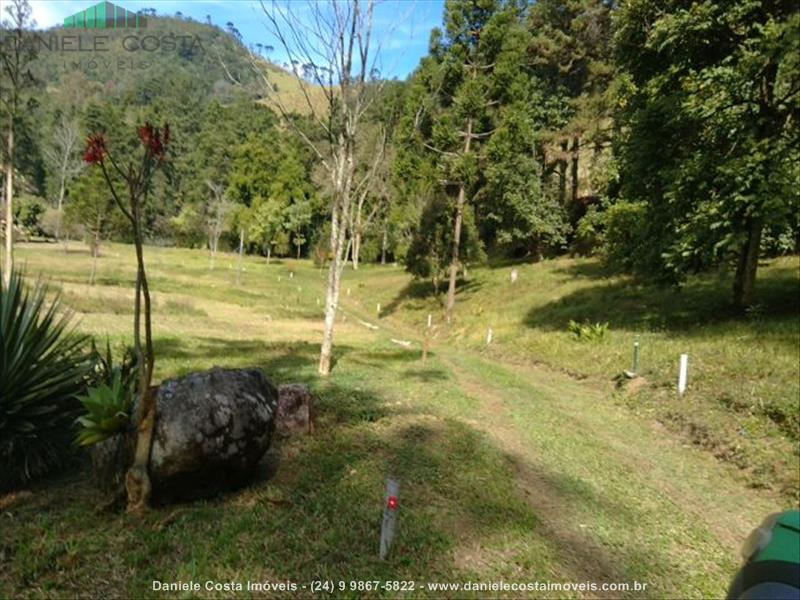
[[355, 257, 800, 502]]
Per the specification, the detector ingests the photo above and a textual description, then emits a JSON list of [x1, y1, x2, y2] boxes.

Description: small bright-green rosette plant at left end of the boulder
[[75, 368, 132, 446]]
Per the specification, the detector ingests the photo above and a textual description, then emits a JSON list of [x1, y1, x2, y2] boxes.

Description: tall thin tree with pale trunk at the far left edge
[[0, 0, 36, 285]]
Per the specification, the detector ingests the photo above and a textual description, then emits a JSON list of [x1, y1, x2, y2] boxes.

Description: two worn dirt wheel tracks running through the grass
[[442, 354, 780, 572]]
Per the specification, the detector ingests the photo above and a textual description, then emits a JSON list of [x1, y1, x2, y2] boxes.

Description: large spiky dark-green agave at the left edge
[[0, 271, 90, 489]]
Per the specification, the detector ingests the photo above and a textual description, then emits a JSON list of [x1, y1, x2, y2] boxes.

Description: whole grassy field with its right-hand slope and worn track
[[0, 244, 798, 598]]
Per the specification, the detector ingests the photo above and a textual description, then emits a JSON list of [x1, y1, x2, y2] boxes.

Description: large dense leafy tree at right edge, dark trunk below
[[616, 0, 800, 307]]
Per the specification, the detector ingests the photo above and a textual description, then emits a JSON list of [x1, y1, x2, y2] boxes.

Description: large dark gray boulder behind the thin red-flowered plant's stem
[[92, 368, 278, 502]]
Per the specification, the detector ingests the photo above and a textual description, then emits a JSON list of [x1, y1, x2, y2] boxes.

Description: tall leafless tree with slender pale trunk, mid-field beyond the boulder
[[253, 0, 383, 375]]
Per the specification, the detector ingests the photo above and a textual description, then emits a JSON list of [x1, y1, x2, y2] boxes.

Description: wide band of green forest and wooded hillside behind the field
[[0, 0, 800, 306]]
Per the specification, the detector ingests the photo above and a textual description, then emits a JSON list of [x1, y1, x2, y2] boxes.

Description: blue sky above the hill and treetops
[[29, 0, 444, 79]]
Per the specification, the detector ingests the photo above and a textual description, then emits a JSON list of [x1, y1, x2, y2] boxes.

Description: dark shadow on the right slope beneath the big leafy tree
[[524, 263, 800, 332]]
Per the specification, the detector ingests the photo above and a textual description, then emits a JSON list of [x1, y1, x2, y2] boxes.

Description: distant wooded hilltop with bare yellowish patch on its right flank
[[34, 16, 321, 114]]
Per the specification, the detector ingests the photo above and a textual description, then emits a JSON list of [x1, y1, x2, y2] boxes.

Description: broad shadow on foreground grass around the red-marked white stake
[[0, 376, 680, 597]]
